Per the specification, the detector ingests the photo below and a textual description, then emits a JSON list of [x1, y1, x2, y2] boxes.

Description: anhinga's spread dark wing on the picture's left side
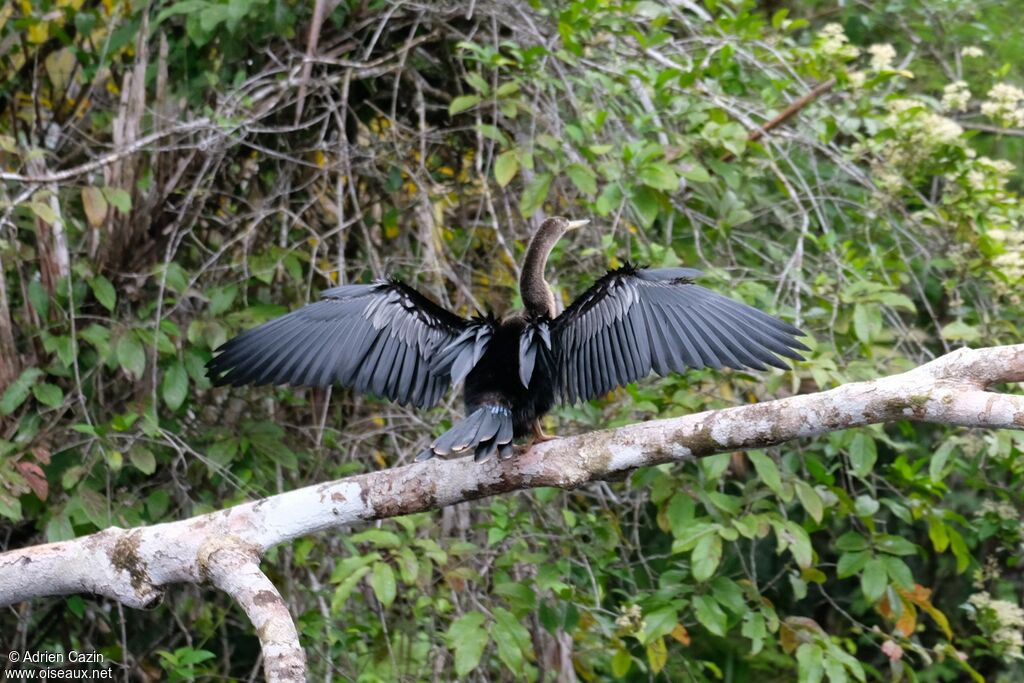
[[207, 281, 490, 408]]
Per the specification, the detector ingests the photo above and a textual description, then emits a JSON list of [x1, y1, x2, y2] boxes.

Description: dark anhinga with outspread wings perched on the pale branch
[[208, 218, 807, 460]]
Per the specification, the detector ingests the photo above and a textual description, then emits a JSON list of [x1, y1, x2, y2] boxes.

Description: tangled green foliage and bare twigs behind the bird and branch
[[0, 0, 1024, 683]]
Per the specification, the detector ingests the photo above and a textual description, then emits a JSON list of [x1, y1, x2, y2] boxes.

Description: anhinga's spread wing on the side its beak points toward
[[552, 264, 807, 402]]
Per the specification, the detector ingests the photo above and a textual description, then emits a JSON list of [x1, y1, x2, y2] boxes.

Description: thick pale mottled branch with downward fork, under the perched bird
[[0, 344, 1024, 681]]
